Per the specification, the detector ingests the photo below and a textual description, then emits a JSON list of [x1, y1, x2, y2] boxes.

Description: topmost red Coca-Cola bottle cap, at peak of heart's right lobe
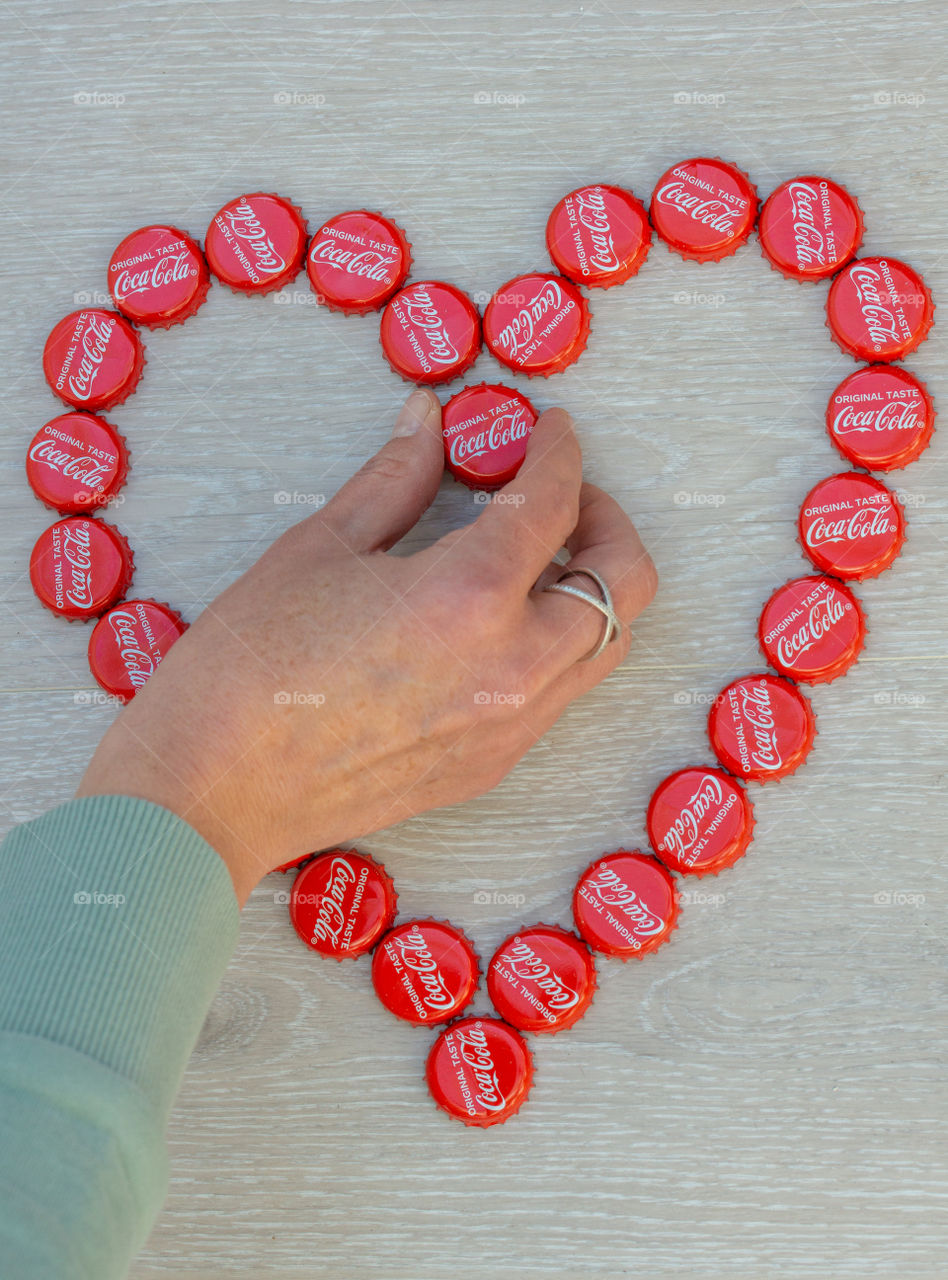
[[649, 156, 757, 262]]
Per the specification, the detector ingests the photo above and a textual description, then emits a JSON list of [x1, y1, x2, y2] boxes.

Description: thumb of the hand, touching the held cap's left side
[[320, 387, 444, 552]]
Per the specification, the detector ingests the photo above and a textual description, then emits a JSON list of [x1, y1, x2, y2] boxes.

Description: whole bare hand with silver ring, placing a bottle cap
[[77, 389, 656, 904]]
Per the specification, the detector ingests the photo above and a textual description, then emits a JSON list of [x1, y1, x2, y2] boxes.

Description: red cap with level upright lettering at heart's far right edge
[[826, 365, 935, 471]]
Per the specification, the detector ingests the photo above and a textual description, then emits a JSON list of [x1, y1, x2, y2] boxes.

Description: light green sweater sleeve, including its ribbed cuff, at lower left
[[0, 796, 239, 1280]]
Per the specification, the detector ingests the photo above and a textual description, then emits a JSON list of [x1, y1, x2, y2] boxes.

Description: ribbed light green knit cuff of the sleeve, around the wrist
[[0, 796, 239, 1116]]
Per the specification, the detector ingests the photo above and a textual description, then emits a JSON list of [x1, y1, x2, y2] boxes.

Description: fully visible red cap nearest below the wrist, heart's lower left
[[289, 849, 398, 960]]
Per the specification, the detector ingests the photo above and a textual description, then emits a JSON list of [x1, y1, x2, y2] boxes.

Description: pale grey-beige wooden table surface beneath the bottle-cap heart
[[0, 0, 948, 1280]]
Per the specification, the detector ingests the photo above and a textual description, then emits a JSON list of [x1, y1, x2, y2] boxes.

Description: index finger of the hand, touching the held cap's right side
[[448, 408, 582, 591]]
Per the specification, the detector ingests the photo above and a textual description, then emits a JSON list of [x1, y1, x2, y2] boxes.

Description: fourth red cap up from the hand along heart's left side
[[42, 307, 145, 412]]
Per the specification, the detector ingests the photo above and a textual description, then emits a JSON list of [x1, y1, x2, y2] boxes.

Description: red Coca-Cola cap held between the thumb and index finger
[[441, 383, 537, 489]]
